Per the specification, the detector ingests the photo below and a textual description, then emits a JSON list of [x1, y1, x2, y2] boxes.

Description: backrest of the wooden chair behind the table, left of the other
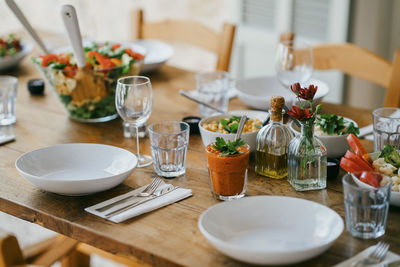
[[132, 9, 236, 71]]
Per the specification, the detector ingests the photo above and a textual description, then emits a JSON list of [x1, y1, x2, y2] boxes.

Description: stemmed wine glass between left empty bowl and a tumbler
[[115, 76, 153, 168]]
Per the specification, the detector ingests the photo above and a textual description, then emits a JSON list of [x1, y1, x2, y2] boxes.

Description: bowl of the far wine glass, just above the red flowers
[[275, 41, 314, 88]]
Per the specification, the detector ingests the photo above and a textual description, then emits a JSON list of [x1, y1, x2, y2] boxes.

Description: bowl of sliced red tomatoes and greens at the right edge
[[340, 134, 400, 206]]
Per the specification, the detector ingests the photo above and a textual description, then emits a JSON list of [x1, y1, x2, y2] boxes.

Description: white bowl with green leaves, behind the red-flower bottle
[[289, 114, 360, 158]]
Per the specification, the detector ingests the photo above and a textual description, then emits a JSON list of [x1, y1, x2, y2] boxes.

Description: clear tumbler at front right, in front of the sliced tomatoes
[[342, 173, 392, 239]]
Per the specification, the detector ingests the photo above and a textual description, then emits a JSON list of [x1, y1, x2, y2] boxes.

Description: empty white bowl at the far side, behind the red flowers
[[236, 76, 329, 110]]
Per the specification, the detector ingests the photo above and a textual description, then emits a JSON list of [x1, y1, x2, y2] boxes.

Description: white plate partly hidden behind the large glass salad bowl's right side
[[134, 39, 174, 72]]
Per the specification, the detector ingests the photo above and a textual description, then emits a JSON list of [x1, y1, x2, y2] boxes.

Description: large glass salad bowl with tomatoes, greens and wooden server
[[32, 43, 144, 122]]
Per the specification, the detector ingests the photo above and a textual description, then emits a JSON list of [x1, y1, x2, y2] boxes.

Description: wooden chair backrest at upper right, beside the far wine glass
[[280, 33, 400, 107]]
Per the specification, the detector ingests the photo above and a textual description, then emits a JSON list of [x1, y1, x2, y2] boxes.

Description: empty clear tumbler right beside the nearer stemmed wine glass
[[148, 121, 189, 178]]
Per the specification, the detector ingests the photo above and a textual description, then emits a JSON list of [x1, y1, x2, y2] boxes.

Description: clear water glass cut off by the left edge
[[0, 75, 18, 125]]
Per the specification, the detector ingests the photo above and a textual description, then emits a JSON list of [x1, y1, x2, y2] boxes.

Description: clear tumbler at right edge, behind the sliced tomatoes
[[372, 108, 400, 151]]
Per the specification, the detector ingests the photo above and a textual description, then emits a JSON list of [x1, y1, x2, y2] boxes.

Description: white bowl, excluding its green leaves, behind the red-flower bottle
[[289, 117, 358, 158]]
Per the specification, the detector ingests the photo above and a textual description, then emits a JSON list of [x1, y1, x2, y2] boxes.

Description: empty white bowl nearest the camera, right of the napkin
[[198, 196, 343, 265]]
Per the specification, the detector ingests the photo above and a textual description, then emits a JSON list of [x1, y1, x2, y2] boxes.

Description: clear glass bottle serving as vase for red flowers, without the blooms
[[288, 122, 327, 191]]
